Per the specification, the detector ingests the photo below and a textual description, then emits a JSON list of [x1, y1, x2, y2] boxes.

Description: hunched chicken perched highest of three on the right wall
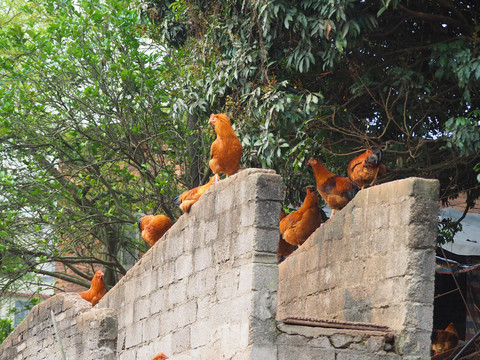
[[347, 149, 387, 190]]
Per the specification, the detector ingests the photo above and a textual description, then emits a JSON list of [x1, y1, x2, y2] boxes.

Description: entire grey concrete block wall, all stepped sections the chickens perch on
[[0, 169, 438, 360]]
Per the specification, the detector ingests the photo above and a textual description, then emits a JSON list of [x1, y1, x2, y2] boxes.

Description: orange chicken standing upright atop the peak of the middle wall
[[208, 114, 242, 180]]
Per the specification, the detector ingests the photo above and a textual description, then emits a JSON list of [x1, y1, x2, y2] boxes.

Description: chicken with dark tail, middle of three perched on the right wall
[[308, 158, 358, 216]]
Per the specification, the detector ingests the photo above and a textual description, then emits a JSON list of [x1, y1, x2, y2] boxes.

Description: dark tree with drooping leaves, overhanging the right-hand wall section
[[139, 0, 480, 207]]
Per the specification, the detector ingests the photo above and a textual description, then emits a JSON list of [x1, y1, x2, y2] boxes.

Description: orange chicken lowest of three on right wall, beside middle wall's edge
[[280, 187, 322, 246]]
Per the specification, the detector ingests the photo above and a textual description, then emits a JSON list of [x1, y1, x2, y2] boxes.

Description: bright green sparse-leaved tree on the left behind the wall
[[0, 0, 212, 291]]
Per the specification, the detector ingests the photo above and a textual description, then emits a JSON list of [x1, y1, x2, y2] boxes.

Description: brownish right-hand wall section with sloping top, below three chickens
[[277, 178, 438, 359]]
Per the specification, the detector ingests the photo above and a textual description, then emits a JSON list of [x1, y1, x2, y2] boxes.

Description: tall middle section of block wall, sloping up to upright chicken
[[99, 169, 283, 360]]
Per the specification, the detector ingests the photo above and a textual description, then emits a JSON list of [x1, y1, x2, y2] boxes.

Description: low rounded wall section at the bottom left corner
[[0, 293, 117, 360]]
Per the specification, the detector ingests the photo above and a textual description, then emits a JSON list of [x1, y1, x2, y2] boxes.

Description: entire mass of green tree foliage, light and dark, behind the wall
[[0, 0, 480, 289]]
